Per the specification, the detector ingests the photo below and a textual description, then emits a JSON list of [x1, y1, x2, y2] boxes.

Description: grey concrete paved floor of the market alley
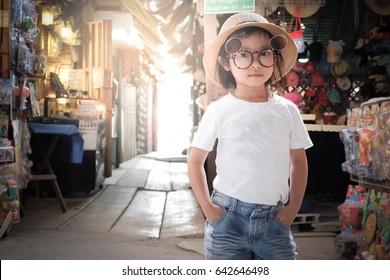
[[0, 155, 341, 260]]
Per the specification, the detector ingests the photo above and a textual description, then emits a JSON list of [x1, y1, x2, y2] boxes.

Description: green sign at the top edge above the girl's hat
[[204, 0, 255, 14]]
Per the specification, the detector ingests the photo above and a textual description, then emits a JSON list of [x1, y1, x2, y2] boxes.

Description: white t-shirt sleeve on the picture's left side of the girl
[[191, 104, 218, 151]]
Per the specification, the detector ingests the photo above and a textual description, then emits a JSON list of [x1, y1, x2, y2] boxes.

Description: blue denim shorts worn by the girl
[[203, 190, 297, 260]]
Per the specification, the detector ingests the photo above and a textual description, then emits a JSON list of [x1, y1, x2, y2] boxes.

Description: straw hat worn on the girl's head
[[203, 12, 298, 87]]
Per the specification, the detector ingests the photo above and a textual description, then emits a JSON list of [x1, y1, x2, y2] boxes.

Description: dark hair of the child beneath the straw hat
[[217, 26, 284, 89]]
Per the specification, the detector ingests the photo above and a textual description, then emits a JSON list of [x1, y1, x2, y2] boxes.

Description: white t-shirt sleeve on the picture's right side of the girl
[[290, 105, 313, 149]]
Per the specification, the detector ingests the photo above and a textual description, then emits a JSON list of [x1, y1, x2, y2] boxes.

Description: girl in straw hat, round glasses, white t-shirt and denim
[[188, 13, 312, 259]]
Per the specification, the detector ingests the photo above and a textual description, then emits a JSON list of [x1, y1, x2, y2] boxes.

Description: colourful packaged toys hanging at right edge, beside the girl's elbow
[[340, 99, 390, 181]]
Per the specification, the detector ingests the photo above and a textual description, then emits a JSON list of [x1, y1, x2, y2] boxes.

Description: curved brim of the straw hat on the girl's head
[[203, 22, 298, 87]]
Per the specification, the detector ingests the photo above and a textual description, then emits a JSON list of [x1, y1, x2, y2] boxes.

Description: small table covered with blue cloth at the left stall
[[28, 122, 84, 212]]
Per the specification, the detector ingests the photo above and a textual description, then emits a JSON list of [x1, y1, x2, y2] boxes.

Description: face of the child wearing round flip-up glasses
[[229, 32, 274, 87]]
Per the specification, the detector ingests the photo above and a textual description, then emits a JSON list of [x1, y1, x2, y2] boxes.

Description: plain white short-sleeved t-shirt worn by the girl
[[191, 94, 313, 205]]
